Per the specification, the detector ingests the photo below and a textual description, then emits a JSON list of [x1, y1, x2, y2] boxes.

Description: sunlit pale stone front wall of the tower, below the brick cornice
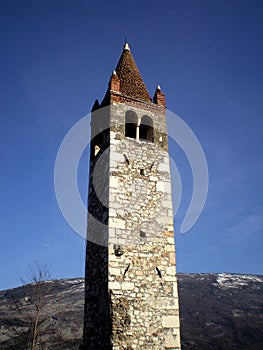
[[108, 104, 180, 350]]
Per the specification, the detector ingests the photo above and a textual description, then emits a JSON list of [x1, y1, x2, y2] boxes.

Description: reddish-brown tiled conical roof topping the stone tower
[[116, 44, 151, 102]]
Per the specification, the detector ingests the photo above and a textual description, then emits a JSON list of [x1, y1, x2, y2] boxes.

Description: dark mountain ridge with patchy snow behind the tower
[[0, 272, 263, 350]]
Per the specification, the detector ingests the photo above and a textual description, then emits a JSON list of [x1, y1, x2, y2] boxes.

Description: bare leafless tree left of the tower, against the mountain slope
[[5, 261, 51, 350]]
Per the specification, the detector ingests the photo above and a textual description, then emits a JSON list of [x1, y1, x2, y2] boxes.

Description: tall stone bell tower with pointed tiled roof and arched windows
[[83, 44, 181, 350]]
